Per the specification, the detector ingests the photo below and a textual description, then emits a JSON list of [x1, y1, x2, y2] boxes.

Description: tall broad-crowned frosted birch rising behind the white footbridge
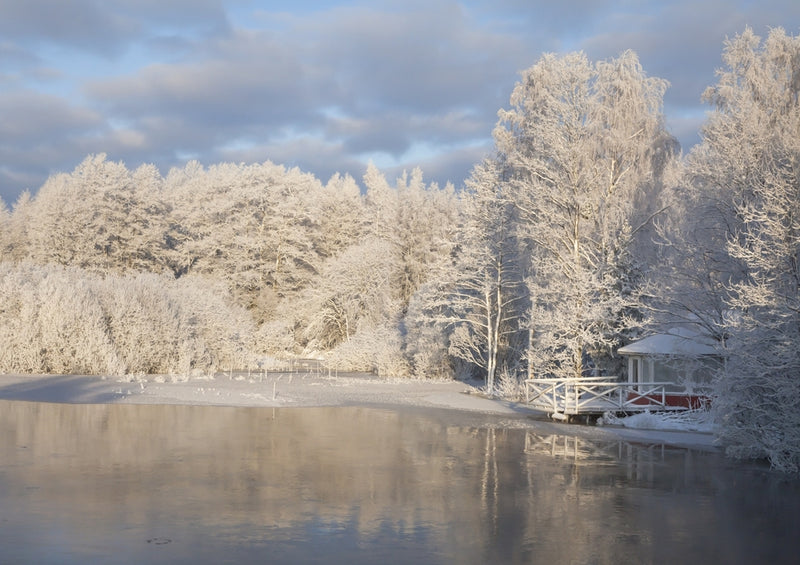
[[494, 51, 670, 377]]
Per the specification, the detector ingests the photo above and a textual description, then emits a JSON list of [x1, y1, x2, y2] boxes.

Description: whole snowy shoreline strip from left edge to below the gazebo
[[0, 373, 716, 450]]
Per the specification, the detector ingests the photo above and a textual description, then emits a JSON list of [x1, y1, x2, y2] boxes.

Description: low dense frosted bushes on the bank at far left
[[0, 261, 253, 375]]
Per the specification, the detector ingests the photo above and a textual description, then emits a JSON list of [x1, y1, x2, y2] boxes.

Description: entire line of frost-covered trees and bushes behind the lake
[[0, 29, 800, 471]]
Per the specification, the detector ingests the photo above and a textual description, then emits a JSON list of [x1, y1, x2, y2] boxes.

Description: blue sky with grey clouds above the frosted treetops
[[0, 0, 800, 206]]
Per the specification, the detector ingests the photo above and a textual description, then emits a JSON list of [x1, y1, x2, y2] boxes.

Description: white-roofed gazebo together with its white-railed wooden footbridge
[[525, 328, 719, 419]]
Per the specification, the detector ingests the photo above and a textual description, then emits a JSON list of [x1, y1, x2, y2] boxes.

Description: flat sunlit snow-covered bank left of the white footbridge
[[0, 372, 537, 415]]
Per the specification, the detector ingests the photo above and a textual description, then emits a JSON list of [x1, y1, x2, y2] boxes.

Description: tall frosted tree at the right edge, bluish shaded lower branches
[[690, 29, 800, 473]]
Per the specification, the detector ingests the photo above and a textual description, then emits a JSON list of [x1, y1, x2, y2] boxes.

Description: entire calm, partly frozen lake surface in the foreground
[[0, 401, 800, 565]]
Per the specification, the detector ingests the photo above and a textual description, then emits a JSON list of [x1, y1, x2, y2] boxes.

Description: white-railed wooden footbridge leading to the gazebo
[[525, 377, 707, 420]]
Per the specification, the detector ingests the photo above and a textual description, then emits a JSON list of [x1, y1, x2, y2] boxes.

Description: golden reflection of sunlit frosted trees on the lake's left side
[[0, 402, 507, 547]]
